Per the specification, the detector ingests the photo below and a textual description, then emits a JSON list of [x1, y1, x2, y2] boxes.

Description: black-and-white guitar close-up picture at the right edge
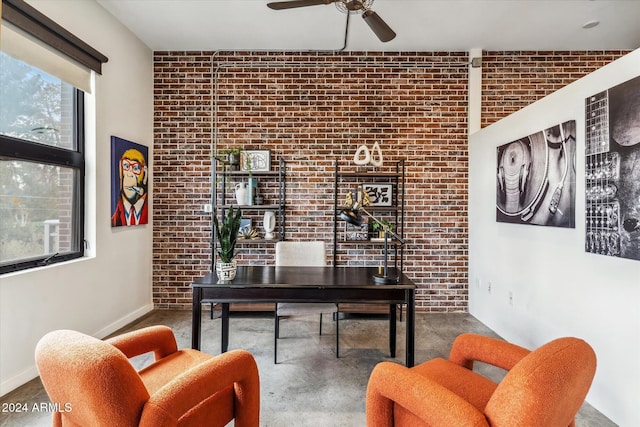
[[585, 77, 640, 260]]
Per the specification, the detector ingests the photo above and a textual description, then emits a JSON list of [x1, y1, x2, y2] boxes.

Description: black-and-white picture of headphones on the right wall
[[496, 120, 576, 228]]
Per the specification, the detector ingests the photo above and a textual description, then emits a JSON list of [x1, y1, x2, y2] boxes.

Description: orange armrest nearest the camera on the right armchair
[[366, 362, 489, 427]]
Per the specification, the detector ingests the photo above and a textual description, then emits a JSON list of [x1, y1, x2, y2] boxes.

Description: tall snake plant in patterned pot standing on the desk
[[213, 206, 242, 280]]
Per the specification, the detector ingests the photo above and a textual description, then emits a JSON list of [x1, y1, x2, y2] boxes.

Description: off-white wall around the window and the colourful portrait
[[0, 0, 153, 395]]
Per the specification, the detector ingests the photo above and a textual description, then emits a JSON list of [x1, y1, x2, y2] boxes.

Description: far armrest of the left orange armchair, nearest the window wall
[[106, 326, 178, 360]]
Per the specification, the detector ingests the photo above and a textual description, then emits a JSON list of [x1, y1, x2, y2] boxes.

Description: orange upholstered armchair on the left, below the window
[[36, 326, 260, 427]]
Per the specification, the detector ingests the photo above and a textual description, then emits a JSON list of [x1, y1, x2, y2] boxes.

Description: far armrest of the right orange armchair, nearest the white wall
[[449, 334, 531, 371]]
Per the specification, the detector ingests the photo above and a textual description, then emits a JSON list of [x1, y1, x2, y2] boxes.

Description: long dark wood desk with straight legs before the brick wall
[[191, 266, 416, 367]]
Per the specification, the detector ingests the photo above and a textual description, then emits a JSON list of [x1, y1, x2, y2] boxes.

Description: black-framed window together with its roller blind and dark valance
[[0, 0, 108, 274]]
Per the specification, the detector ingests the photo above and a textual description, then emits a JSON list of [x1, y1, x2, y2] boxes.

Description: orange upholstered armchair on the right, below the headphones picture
[[367, 334, 596, 427]]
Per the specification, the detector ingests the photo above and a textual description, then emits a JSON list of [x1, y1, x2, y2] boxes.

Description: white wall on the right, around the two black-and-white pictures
[[469, 50, 640, 426]]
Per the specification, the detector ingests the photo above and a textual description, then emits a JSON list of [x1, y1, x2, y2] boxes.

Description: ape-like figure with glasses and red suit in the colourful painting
[[111, 149, 148, 227]]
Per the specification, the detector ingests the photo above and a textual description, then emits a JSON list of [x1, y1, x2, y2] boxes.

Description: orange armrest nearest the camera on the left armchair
[[140, 350, 260, 427]]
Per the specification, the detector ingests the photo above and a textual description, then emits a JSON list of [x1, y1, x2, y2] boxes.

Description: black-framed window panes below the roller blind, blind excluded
[[0, 52, 84, 273]]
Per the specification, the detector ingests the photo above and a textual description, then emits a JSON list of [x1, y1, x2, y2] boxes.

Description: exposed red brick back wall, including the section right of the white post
[[152, 52, 621, 312]]
